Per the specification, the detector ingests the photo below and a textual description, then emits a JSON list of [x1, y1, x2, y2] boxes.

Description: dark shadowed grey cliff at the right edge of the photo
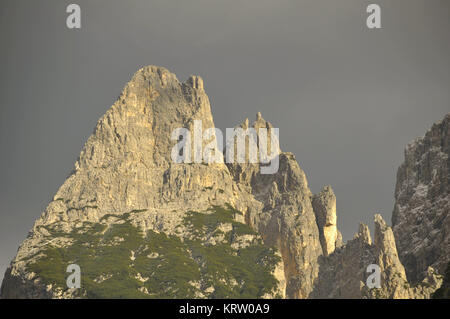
[[392, 114, 450, 282]]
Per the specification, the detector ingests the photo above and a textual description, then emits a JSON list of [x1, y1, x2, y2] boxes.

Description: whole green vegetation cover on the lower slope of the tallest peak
[[28, 207, 280, 298]]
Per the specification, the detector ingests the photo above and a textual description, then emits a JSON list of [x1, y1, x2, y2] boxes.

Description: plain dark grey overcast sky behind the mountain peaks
[[0, 0, 450, 284]]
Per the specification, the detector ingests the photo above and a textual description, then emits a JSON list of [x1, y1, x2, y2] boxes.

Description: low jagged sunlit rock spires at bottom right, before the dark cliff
[[311, 214, 442, 299]]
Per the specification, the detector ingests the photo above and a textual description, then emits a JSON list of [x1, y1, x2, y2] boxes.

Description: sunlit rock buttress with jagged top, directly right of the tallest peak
[[228, 114, 322, 298]]
